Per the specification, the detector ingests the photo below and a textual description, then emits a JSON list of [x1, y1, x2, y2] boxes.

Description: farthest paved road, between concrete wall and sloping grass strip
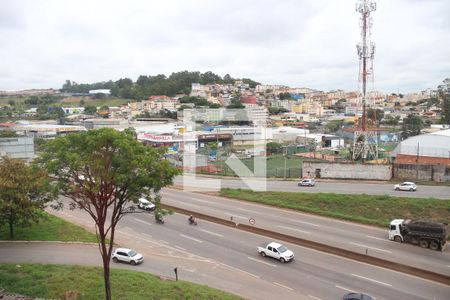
[[174, 176, 450, 200]]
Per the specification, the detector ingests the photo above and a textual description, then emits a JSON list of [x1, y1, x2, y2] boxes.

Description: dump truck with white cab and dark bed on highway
[[389, 219, 450, 251]]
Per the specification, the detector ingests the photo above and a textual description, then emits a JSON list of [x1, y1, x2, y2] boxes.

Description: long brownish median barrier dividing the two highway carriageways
[[161, 204, 450, 285]]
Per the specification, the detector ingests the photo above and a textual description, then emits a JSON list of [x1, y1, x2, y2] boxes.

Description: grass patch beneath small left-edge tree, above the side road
[[0, 212, 97, 243]]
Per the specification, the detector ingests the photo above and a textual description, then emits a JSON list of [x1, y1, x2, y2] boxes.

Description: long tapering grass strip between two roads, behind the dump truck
[[220, 189, 450, 227]]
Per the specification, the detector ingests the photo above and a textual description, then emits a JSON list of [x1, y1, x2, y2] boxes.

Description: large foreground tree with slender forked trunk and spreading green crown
[[37, 128, 178, 300]]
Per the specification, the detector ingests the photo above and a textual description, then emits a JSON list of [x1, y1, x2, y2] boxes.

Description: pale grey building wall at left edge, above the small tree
[[0, 136, 34, 159]]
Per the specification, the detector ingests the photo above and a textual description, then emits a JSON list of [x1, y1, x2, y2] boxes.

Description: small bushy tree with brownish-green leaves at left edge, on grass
[[0, 156, 56, 240]]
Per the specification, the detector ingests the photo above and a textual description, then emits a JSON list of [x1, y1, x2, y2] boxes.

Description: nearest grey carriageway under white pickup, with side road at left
[[11, 202, 450, 300]]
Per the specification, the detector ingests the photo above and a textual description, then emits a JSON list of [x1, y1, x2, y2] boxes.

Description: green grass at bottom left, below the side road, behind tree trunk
[[0, 264, 242, 300]]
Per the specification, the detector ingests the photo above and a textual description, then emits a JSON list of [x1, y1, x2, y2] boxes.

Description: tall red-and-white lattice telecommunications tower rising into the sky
[[352, 0, 378, 161]]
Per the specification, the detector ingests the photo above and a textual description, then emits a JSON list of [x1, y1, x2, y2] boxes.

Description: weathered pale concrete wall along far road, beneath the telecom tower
[[302, 162, 392, 180]]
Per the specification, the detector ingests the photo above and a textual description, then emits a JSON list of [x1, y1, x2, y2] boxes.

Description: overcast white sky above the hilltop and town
[[0, 0, 450, 93]]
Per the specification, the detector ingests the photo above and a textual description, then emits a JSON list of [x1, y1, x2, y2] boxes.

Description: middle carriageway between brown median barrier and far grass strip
[[162, 189, 450, 276]]
